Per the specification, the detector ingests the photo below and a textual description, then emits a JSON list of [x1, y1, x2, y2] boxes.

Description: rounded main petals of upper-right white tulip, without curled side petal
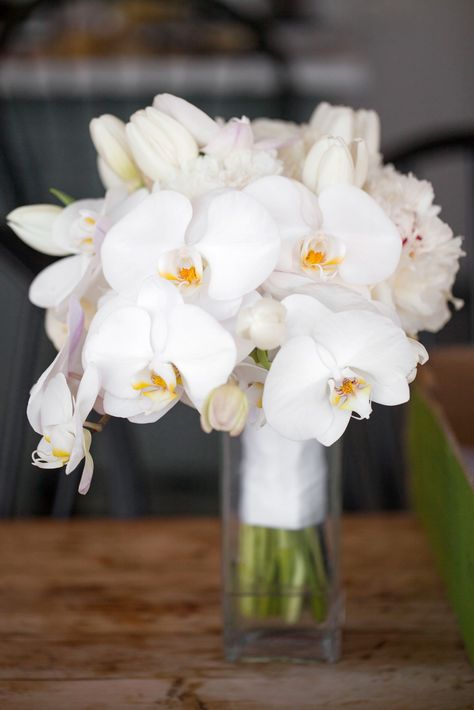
[[303, 136, 355, 194]]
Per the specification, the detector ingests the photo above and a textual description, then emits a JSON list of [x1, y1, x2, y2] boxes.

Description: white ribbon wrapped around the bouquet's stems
[[240, 424, 328, 530]]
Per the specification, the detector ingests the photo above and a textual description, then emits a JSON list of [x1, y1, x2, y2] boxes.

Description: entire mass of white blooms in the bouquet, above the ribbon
[[8, 94, 462, 492]]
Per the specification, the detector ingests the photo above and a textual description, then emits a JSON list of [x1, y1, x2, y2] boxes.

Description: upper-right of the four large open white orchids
[[245, 176, 402, 286]]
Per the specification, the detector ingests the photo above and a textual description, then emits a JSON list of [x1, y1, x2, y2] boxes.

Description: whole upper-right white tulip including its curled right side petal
[[302, 136, 369, 195]]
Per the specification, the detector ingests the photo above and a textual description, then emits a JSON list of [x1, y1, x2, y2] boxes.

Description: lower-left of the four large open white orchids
[[83, 278, 236, 423]]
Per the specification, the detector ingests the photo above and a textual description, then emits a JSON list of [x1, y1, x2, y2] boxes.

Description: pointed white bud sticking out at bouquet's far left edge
[[7, 205, 69, 256]]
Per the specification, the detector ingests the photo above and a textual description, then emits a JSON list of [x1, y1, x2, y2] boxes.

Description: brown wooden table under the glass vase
[[0, 516, 474, 710]]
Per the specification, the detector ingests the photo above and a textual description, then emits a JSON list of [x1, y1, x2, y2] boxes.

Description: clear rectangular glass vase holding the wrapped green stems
[[221, 425, 343, 662]]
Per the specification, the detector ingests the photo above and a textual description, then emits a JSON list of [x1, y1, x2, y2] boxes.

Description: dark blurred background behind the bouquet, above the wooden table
[[0, 0, 474, 517]]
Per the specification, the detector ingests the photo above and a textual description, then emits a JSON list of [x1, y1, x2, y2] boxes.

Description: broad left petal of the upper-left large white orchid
[[101, 190, 192, 291]]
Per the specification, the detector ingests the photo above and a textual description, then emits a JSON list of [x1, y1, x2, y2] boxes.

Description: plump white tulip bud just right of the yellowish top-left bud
[[126, 106, 198, 180]]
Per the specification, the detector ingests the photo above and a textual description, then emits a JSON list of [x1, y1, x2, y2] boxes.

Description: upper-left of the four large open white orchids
[[102, 185, 279, 304]]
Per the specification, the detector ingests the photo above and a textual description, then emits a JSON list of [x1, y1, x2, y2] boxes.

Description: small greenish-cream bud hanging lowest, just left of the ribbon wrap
[[201, 383, 249, 436]]
